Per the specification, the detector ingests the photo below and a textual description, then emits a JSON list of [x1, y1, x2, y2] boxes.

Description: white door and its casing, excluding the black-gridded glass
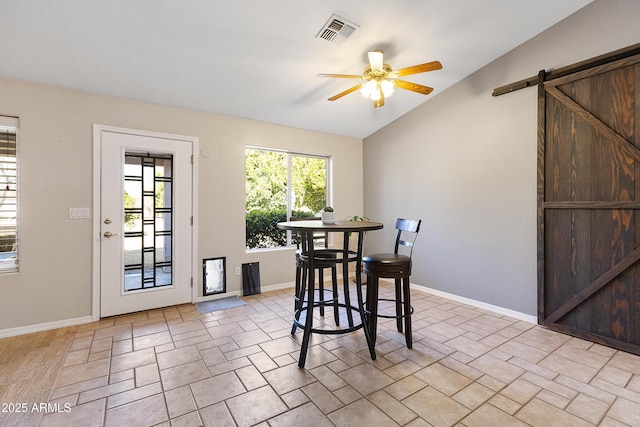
[[93, 125, 198, 320]]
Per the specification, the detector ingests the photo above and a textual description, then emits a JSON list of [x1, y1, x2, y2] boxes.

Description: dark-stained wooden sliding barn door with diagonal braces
[[538, 55, 640, 354]]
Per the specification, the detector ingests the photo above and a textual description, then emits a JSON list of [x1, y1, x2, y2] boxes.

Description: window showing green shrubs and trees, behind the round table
[[245, 148, 329, 249]]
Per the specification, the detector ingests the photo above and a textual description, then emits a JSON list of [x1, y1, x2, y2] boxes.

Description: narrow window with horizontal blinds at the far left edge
[[0, 116, 18, 272]]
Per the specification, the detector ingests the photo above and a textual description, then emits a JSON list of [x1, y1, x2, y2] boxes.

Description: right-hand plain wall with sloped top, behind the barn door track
[[364, 0, 640, 315]]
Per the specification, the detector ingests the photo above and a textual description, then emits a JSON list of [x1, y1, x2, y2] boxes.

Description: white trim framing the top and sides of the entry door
[[91, 124, 200, 321]]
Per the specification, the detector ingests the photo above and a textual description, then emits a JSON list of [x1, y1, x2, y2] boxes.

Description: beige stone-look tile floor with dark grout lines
[[0, 284, 640, 427]]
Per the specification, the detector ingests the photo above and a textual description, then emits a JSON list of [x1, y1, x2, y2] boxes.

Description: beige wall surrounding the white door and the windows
[[0, 79, 363, 332]]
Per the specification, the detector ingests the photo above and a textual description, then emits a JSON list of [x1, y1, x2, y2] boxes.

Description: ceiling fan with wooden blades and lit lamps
[[318, 50, 442, 108]]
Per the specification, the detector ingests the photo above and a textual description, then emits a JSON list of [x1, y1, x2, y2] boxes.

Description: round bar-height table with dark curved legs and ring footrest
[[278, 220, 383, 368]]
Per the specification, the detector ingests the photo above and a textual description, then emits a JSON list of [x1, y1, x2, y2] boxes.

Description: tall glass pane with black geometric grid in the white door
[[124, 153, 173, 291]]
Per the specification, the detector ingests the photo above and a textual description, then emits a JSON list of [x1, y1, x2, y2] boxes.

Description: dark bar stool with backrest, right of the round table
[[362, 218, 422, 348]]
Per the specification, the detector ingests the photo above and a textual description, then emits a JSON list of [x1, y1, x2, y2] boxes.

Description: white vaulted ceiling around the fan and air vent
[[0, 0, 591, 138]]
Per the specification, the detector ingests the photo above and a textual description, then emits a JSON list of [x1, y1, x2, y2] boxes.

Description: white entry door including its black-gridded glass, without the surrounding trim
[[99, 129, 194, 317]]
